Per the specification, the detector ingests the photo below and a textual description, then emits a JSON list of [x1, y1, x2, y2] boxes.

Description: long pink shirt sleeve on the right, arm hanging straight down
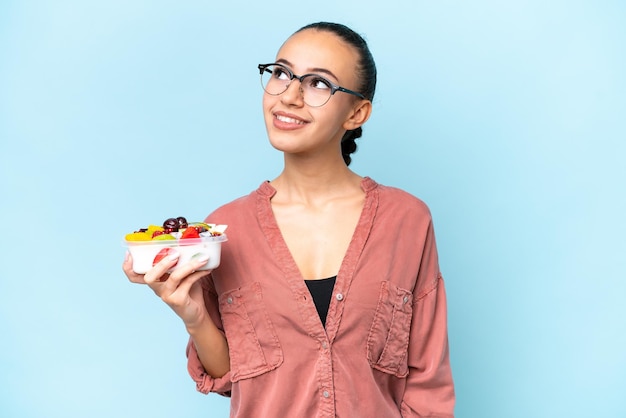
[[401, 223, 455, 418]]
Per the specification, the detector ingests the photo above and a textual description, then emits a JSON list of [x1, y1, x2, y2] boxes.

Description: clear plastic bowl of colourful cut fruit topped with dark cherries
[[124, 216, 228, 274]]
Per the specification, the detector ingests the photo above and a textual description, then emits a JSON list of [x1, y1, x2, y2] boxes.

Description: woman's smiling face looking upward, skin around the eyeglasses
[[263, 29, 369, 157]]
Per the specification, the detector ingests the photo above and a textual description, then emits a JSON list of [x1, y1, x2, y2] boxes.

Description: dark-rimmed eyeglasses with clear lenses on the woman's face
[[259, 64, 366, 107]]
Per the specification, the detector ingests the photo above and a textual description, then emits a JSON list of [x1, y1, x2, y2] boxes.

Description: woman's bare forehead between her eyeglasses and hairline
[[276, 29, 358, 82]]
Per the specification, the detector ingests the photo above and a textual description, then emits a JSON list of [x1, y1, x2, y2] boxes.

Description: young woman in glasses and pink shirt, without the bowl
[[124, 22, 455, 418]]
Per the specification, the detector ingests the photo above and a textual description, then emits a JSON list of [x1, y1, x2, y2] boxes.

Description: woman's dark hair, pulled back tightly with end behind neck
[[296, 22, 376, 165]]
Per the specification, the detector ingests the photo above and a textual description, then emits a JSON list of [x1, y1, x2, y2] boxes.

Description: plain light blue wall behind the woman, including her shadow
[[0, 0, 626, 418]]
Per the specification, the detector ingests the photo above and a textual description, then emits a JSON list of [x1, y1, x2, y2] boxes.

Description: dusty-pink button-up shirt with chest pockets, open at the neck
[[187, 178, 455, 418]]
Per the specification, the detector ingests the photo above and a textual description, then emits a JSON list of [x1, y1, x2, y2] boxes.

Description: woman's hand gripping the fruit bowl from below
[[122, 248, 210, 329]]
